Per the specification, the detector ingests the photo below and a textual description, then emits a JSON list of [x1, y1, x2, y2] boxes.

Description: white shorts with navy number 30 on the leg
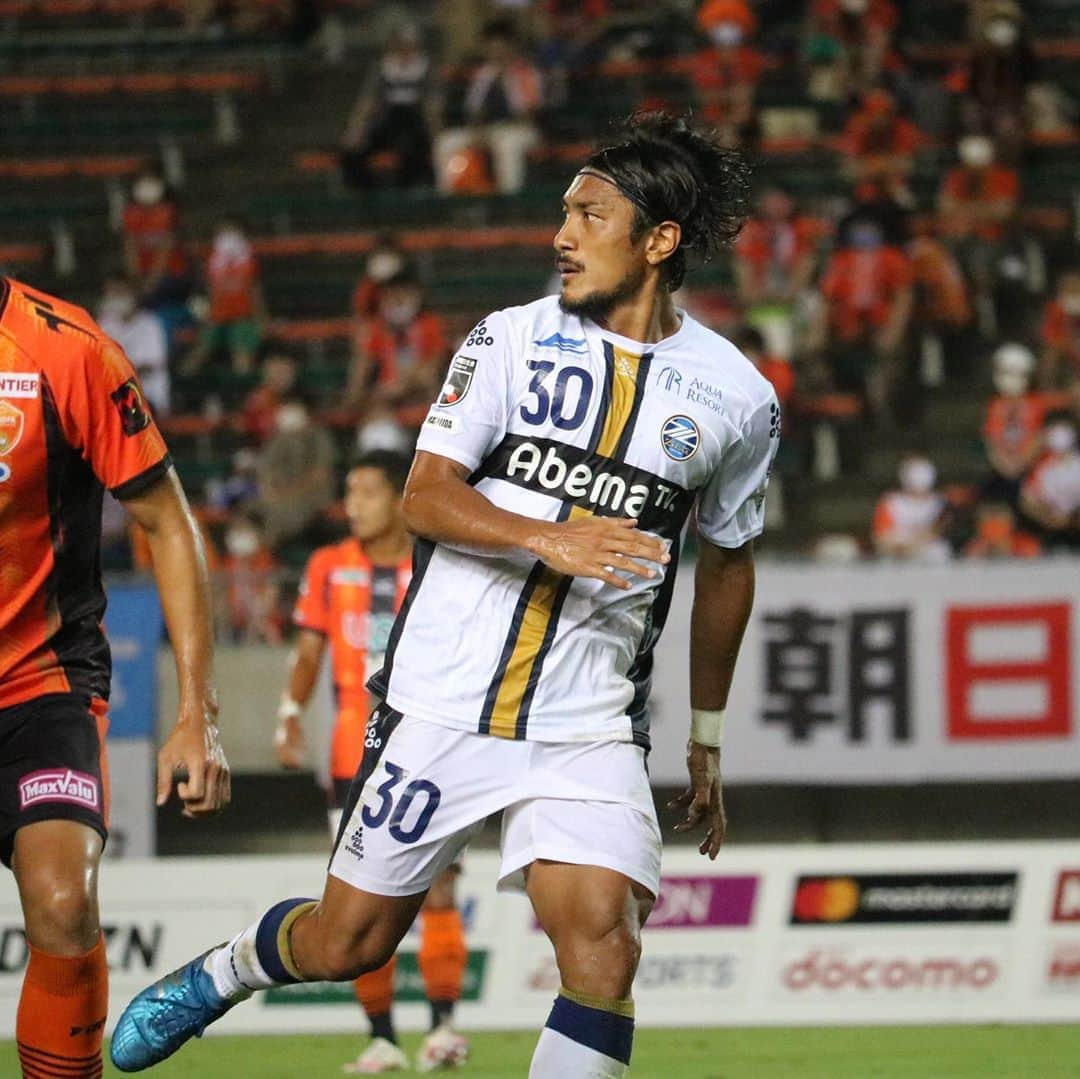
[[329, 710, 660, 895]]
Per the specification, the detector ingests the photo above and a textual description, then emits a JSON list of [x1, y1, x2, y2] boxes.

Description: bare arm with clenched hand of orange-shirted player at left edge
[[124, 468, 230, 817]]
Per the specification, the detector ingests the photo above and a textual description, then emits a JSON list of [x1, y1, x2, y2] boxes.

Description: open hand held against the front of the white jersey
[[534, 517, 671, 590]]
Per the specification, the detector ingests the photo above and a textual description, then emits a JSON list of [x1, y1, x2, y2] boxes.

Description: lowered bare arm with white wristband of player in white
[[672, 540, 754, 859]]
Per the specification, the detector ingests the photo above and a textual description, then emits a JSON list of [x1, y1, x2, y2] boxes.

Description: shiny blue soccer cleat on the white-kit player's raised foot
[[109, 952, 251, 1071]]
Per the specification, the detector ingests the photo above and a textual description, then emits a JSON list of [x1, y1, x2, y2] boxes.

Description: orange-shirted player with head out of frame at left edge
[[0, 279, 229, 1079]]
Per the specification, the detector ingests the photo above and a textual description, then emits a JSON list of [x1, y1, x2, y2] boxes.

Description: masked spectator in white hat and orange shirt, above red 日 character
[[982, 343, 1047, 508]]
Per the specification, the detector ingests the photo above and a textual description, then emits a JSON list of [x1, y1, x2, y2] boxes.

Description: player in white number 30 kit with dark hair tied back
[[112, 116, 780, 1079]]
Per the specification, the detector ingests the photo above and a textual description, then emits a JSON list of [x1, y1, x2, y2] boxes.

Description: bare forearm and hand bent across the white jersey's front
[[404, 450, 670, 589]]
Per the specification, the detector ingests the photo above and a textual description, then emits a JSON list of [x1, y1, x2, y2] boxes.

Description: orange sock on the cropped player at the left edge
[[15, 938, 109, 1079]]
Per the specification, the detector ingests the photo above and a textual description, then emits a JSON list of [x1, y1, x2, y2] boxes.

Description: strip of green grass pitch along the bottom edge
[[6, 1025, 1080, 1079]]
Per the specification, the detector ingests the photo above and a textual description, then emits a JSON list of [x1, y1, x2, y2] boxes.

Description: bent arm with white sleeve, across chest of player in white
[[404, 312, 669, 589]]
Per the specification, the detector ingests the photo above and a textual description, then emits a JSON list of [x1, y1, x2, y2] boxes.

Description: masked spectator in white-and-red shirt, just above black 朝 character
[[873, 454, 949, 563]]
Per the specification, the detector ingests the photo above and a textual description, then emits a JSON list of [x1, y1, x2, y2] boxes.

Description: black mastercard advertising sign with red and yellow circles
[[789, 873, 1017, 926]]
